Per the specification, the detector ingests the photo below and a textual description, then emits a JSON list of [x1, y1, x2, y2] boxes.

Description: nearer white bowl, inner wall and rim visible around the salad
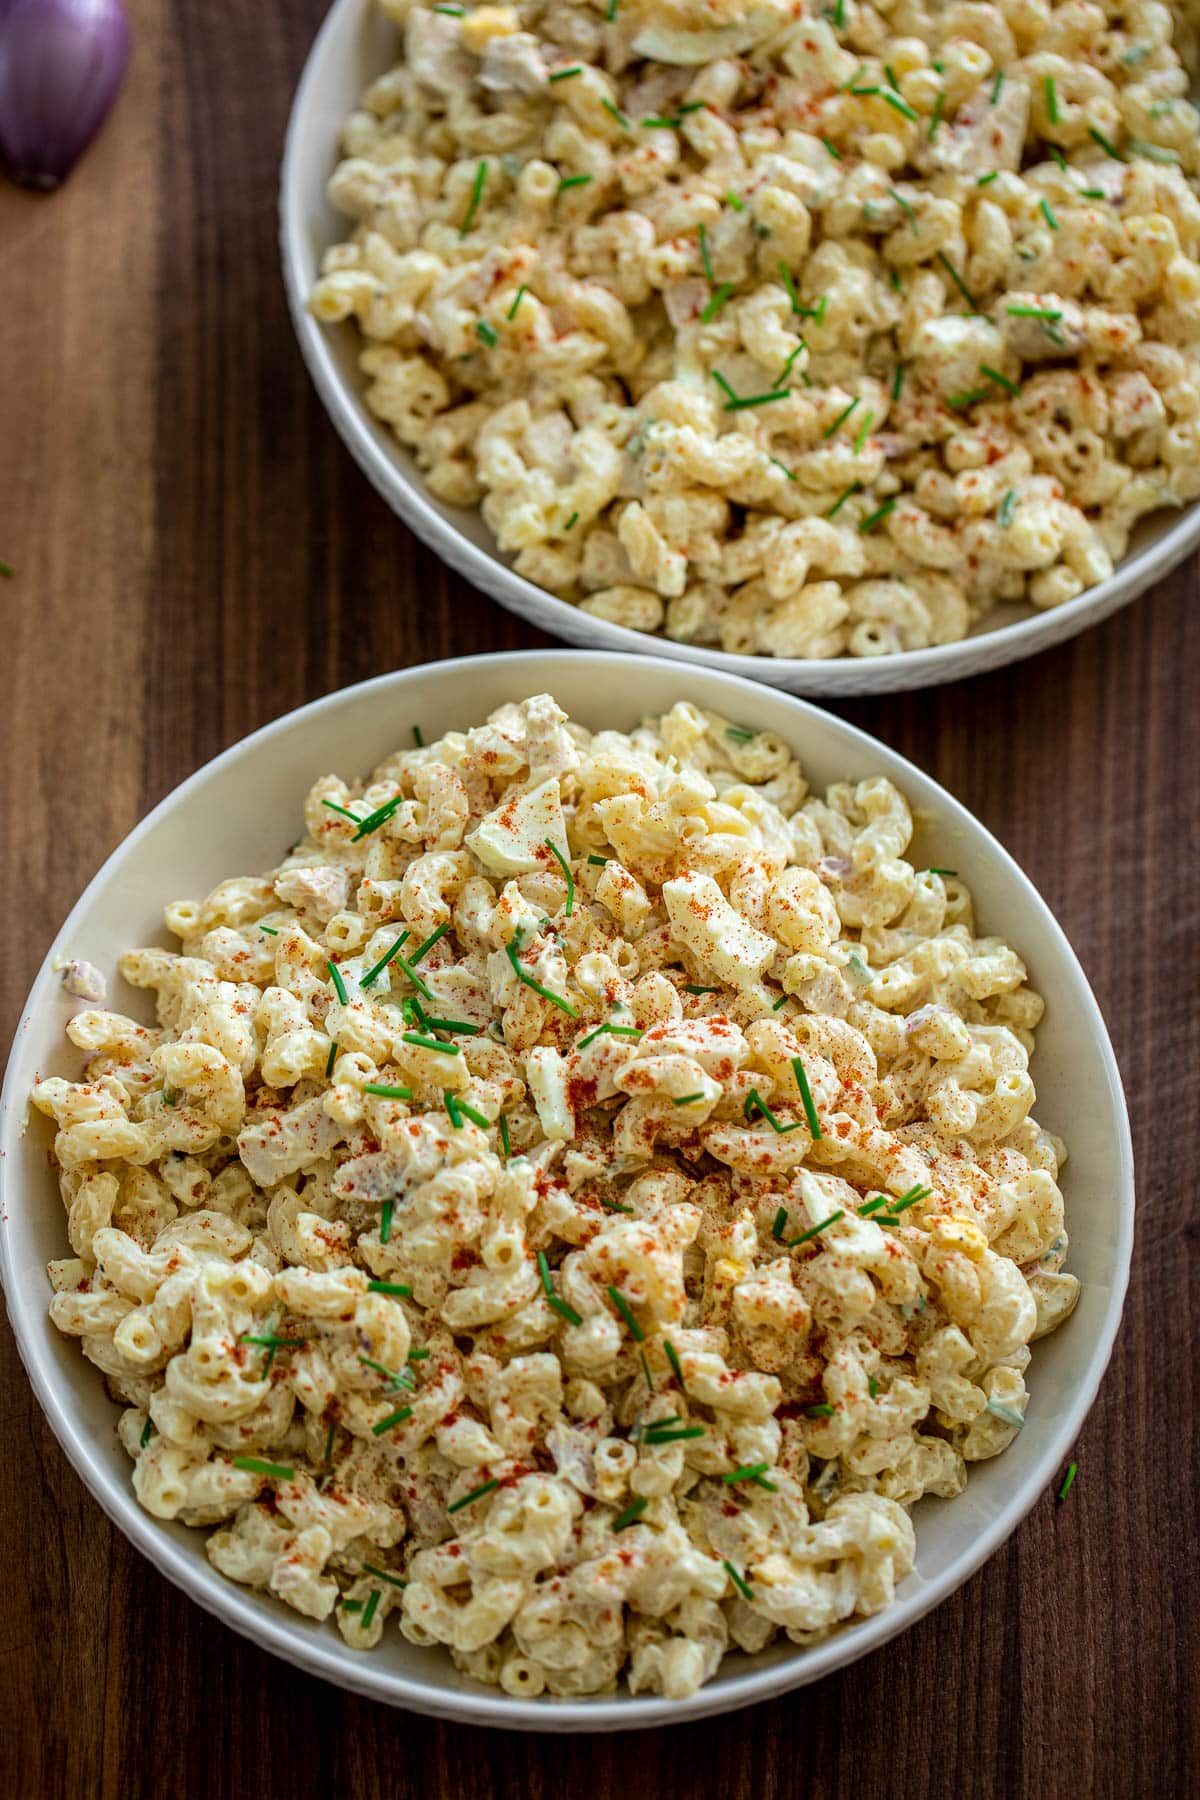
[[0, 650, 1133, 1732]]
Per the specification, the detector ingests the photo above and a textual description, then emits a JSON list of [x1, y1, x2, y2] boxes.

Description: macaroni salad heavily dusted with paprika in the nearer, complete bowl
[[32, 695, 1079, 1696]]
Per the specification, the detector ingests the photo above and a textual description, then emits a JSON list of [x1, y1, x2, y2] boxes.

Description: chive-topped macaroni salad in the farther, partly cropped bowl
[[309, 0, 1200, 657]]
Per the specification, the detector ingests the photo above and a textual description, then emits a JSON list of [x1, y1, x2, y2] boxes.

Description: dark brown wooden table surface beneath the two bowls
[[0, 0, 1200, 1800]]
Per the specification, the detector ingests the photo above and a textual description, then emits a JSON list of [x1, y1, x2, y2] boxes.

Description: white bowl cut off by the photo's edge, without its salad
[[279, 0, 1200, 695]]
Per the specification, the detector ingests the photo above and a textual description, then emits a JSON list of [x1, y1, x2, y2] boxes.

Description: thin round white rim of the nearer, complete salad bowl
[[0, 648, 1133, 1732]]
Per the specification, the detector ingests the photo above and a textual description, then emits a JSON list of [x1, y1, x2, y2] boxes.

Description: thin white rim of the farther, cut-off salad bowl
[[279, 0, 1200, 695]]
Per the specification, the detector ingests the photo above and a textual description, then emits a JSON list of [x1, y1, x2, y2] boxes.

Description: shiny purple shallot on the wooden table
[[0, 0, 130, 189]]
